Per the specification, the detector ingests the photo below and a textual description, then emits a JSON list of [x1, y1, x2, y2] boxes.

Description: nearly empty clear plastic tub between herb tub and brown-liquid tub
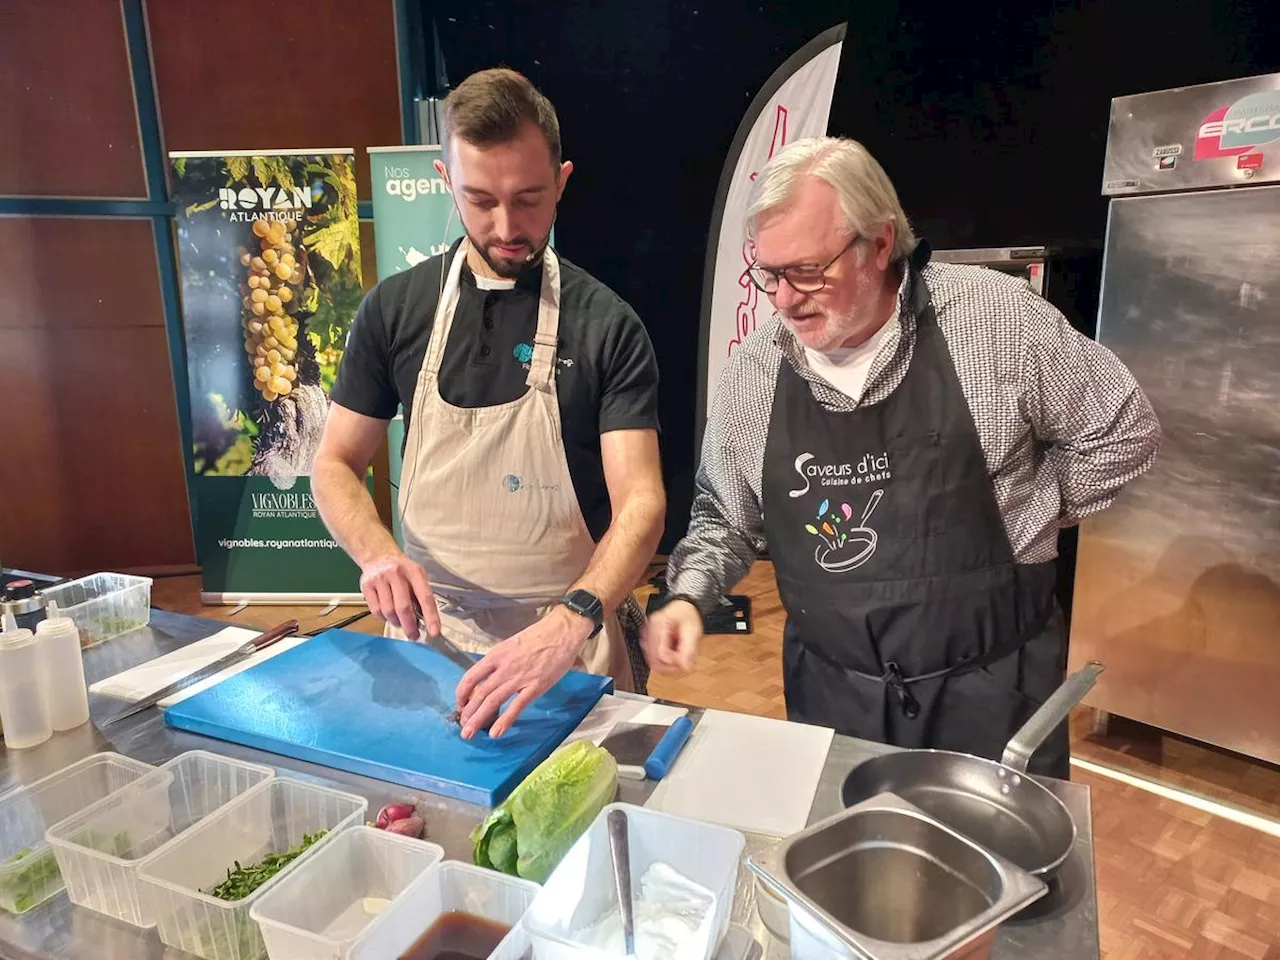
[[248, 826, 444, 960]]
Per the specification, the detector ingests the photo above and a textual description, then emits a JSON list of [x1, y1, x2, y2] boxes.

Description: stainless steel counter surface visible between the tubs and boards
[[0, 611, 1098, 960]]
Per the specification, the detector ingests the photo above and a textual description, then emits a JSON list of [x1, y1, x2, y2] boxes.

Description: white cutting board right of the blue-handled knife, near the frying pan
[[645, 710, 835, 838]]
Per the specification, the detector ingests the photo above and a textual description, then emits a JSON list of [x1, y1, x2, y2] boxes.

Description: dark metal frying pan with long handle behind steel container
[[842, 660, 1106, 878]]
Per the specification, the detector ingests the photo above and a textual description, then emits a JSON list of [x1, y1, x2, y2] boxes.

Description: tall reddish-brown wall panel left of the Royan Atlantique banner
[[0, 218, 195, 573]]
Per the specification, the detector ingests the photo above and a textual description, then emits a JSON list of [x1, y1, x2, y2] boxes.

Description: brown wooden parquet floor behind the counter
[[152, 562, 1280, 960]]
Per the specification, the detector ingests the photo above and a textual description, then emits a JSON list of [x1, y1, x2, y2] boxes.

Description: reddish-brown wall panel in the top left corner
[[0, 0, 146, 198]]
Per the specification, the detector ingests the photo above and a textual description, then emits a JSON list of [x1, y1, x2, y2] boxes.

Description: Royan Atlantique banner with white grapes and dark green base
[[169, 148, 364, 603]]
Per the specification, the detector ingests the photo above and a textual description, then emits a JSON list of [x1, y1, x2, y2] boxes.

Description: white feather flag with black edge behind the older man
[[695, 23, 846, 456]]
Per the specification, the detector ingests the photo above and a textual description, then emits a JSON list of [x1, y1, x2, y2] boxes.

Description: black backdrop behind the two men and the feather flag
[[421, 0, 1280, 550]]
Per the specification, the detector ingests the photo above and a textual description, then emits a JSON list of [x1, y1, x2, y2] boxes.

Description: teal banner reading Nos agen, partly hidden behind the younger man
[[369, 146, 462, 544]]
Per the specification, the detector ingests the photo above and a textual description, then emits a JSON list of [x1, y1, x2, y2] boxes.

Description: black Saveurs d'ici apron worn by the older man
[[763, 242, 1070, 780]]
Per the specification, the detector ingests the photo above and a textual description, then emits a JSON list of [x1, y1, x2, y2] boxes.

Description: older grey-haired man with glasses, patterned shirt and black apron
[[645, 138, 1160, 777]]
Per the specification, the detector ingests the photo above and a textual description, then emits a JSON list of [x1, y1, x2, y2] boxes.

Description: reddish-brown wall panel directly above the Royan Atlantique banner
[[147, 0, 401, 200]]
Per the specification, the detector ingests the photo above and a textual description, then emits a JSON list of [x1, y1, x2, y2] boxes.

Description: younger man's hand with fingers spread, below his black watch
[[457, 607, 591, 740]]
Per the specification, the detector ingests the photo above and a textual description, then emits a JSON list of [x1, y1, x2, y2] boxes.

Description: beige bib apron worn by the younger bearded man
[[387, 239, 632, 690]]
